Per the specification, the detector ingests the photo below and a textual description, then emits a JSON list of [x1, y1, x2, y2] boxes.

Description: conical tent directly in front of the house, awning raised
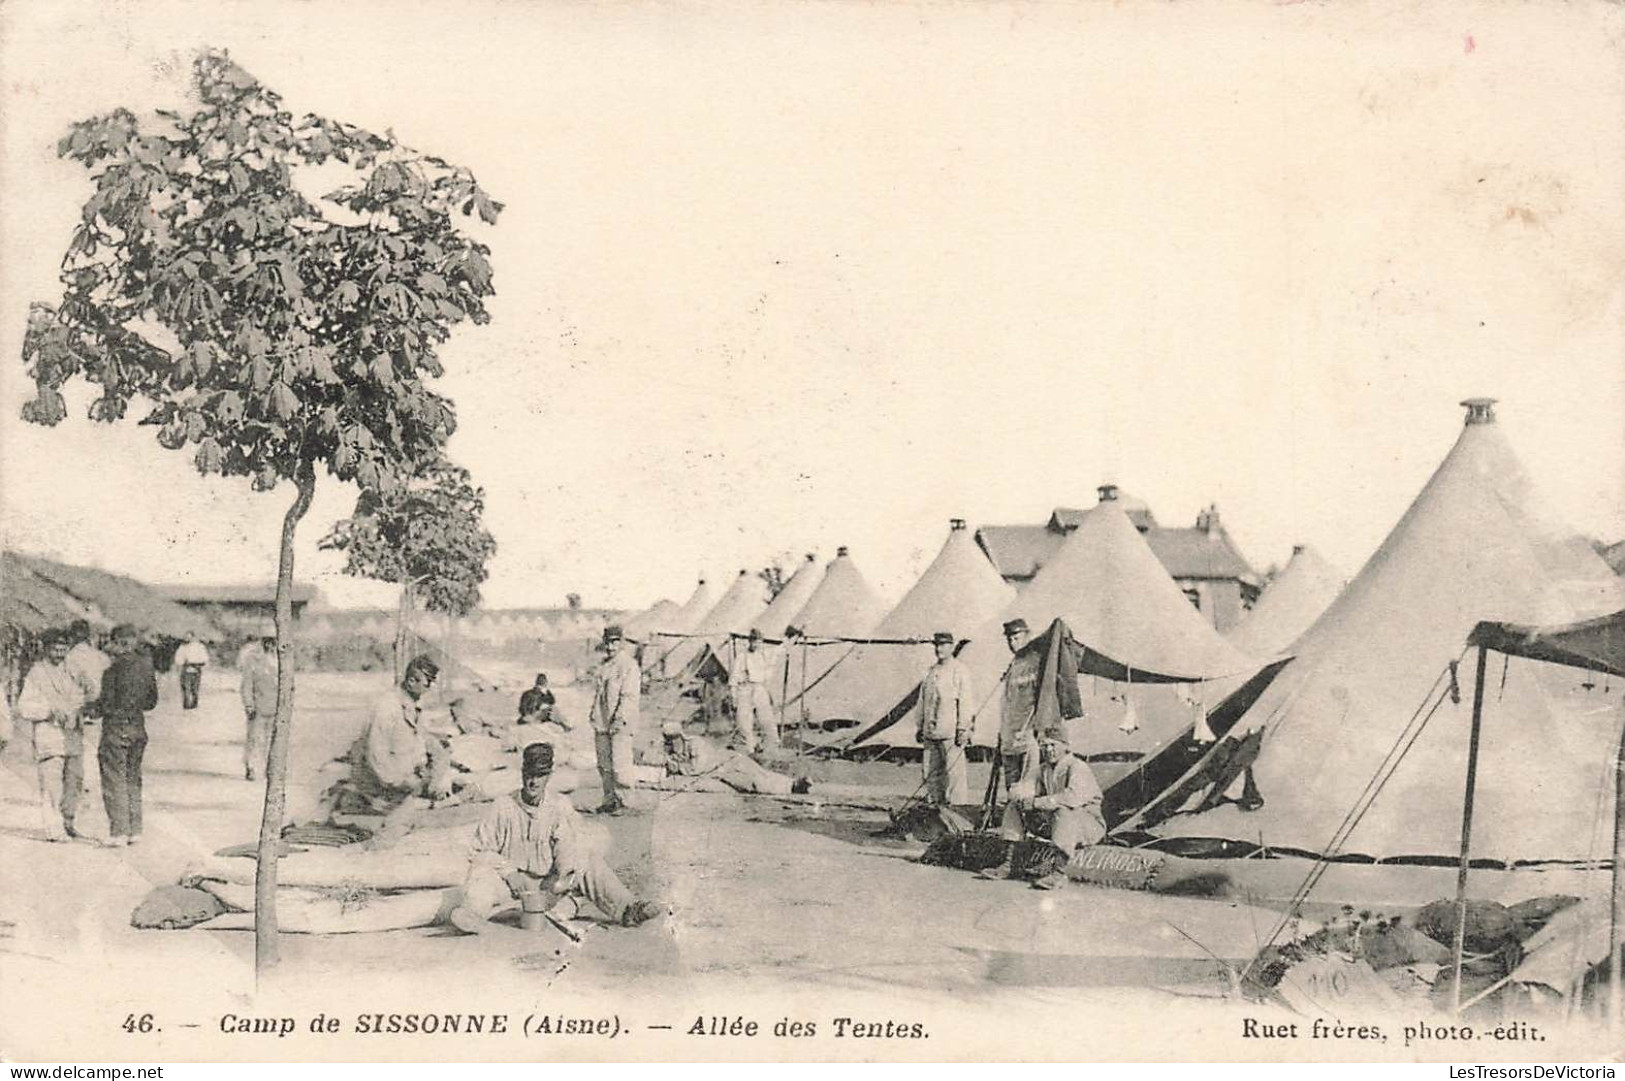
[[949, 499, 1258, 761]]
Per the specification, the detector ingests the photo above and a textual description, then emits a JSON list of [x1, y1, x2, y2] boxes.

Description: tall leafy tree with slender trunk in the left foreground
[[23, 52, 501, 974]]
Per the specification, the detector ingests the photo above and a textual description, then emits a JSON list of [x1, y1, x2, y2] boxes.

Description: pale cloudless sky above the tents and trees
[[0, 0, 1625, 608]]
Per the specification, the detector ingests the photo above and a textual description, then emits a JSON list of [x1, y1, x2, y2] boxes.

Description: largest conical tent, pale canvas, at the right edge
[[1131, 400, 1625, 862]]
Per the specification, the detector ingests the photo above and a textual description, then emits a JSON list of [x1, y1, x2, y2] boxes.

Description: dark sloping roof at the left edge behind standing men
[[0, 551, 219, 640]]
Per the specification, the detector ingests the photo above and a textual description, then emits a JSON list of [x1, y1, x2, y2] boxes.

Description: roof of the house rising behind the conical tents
[[977, 507, 1258, 582]]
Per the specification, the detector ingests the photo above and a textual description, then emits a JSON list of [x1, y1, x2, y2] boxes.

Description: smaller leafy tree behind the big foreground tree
[[320, 457, 497, 679]]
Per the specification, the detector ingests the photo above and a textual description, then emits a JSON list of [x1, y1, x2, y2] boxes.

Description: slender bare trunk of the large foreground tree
[[254, 462, 315, 985]]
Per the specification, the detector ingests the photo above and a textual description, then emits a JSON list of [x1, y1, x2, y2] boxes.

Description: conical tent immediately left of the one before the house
[[804, 519, 1016, 728]]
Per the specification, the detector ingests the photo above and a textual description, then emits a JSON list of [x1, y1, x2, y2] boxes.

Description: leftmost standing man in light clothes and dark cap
[[16, 631, 85, 840]]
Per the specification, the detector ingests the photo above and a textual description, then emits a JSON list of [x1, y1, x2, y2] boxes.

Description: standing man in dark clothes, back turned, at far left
[[96, 623, 158, 845]]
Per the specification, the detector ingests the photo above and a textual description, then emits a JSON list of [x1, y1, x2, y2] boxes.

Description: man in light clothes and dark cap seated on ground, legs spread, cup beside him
[[447, 743, 660, 935]]
